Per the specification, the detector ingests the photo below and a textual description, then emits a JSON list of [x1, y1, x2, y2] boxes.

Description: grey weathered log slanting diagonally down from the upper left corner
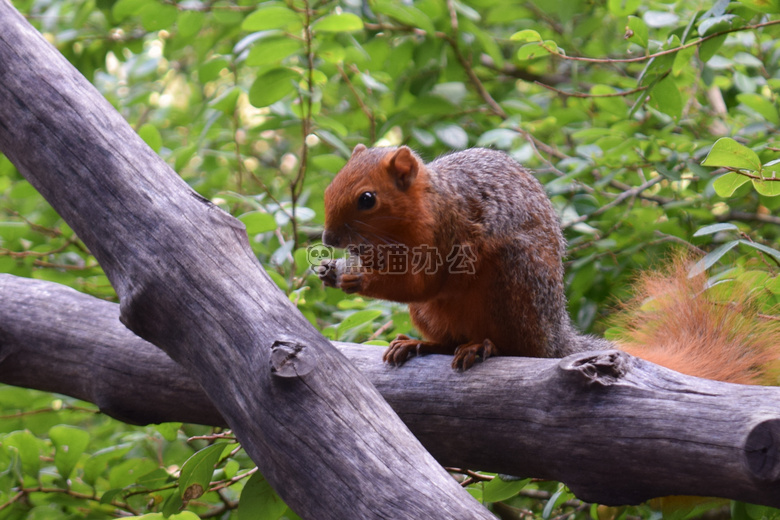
[[0, 0, 490, 519]]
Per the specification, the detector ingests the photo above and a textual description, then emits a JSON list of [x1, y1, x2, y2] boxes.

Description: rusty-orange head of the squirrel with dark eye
[[322, 144, 429, 252]]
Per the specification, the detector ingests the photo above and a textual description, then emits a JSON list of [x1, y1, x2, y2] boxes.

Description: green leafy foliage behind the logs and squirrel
[[0, 0, 780, 519]]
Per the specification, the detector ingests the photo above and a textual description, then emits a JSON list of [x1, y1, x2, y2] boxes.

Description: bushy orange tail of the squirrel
[[611, 259, 780, 385]]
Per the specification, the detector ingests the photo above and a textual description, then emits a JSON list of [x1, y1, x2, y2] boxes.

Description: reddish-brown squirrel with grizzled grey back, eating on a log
[[317, 144, 780, 383]]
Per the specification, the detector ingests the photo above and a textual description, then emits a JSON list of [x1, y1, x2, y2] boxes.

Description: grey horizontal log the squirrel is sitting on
[[0, 275, 780, 507]]
